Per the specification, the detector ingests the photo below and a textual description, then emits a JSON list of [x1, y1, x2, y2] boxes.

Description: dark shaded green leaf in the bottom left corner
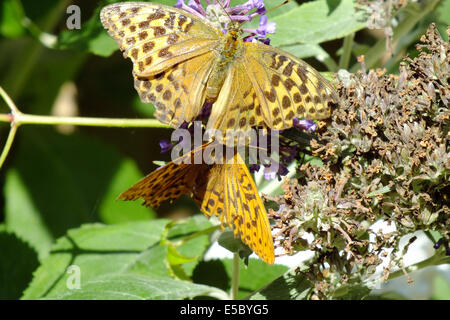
[[0, 231, 38, 300]]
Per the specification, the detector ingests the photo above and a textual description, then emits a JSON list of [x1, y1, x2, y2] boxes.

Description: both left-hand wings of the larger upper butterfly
[[100, 2, 220, 127]]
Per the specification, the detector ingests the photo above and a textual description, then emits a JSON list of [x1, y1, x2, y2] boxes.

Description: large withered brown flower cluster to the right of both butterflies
[[265, 25, 450, 299]]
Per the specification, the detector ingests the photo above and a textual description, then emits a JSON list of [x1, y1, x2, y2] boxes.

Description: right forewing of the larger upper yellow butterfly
[[243, 42, 338, 130]]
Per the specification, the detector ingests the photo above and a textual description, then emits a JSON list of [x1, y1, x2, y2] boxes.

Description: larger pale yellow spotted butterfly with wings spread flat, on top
[[100, 2, 337, 135]]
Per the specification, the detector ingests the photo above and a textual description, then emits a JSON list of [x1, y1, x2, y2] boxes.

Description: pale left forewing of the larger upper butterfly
[[100, 2, 217, 76]]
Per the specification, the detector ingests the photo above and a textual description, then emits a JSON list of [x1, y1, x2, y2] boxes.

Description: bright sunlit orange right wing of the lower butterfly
[[201, 153, 275, 264]]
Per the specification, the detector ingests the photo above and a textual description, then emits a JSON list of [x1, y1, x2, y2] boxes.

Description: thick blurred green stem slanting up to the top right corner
[[350, 0, 441, 73]]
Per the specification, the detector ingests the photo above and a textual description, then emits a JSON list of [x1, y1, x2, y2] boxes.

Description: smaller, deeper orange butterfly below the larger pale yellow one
[[118, 142, 275, 264]]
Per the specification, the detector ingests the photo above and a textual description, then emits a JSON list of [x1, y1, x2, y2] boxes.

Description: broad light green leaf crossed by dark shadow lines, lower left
[[23, 220, 168, 299]]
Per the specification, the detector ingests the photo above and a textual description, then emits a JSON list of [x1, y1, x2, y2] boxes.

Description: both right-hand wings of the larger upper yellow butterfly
[[207, 43, 338, 136]]
